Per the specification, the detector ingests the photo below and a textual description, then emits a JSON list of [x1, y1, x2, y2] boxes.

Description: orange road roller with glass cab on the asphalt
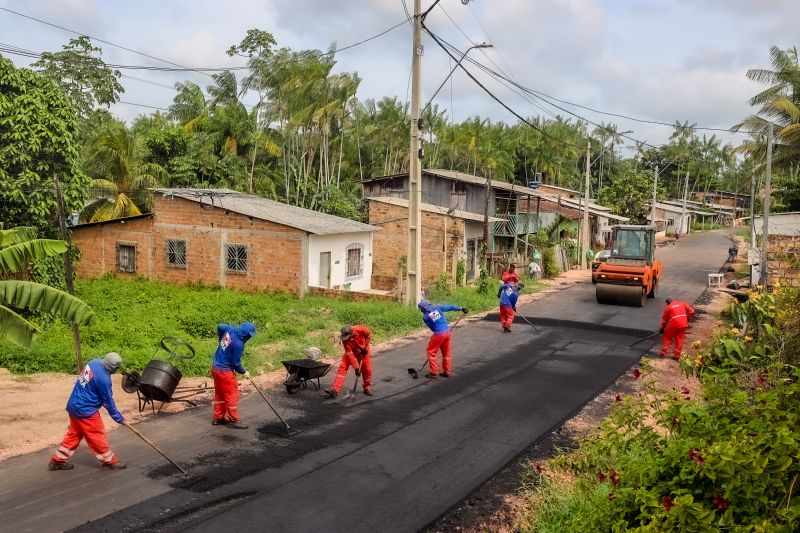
[[595, 226, 663, 307]]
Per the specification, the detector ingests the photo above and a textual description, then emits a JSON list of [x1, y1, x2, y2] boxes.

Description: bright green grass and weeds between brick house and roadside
[[0, 276, 535, 375]]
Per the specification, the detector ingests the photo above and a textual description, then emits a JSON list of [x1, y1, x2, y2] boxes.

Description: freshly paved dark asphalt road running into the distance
[[0, 232, 729, 533]]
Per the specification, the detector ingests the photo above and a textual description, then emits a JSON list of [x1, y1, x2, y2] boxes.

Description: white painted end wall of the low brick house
[[308, 231, 372, 291]]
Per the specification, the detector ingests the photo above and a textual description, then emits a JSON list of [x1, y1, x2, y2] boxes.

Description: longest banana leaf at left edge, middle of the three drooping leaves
[[0, 280, 94, 326]]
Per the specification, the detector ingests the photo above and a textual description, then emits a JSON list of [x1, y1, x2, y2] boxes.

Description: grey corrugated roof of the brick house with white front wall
[[154, 189, 380, 235]]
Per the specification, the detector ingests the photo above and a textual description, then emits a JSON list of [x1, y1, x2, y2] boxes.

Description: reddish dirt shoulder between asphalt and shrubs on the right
[[426, 284, 731, 533]]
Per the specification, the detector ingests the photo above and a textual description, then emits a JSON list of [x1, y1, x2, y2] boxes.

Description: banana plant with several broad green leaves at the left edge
[[0, 224, 94, 348]]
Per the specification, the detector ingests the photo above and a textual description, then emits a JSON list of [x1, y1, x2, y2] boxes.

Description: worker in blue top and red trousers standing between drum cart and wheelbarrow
[[211, 322, 256, 429]]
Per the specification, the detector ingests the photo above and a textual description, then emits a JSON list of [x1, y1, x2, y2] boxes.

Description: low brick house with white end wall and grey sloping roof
[[72, 189, 379, 295]]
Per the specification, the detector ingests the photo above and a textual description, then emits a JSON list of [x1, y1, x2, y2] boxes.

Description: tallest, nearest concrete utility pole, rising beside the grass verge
[[406, 0, 423, 303]]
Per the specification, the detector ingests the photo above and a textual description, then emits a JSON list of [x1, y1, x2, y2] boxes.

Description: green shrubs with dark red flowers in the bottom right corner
[[521, 291, 800, 532]]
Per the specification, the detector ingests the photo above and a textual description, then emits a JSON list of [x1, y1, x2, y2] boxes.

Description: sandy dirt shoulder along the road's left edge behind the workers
[[0, 271, 588, 461]]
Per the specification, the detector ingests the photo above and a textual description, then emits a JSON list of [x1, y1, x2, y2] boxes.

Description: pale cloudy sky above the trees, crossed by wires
[[0, 0, 800, 148]]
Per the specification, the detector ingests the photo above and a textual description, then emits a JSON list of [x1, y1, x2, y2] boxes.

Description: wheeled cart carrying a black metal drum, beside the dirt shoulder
[[122, 337, 213, 413]]
